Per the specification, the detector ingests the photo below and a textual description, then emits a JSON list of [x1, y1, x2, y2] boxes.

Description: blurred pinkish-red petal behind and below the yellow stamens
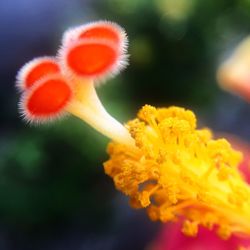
[[149, 134, 250, 250]]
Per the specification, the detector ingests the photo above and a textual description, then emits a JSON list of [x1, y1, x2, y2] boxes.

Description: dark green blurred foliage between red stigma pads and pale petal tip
[[96, 0, 250, 109]]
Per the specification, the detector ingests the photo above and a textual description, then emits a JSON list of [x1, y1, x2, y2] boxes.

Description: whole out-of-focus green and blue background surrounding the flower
[[0, 0, 250, 250]]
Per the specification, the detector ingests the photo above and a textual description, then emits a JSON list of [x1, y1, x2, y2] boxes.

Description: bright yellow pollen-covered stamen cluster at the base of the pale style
[[104, 105, 250, 239]]
